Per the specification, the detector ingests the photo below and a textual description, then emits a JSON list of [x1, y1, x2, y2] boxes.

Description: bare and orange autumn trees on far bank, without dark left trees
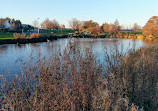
[[36, 16, 158, 37]]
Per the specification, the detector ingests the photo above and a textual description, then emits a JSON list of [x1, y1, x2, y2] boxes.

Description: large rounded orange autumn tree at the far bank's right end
[[142, 16, 158, 37]]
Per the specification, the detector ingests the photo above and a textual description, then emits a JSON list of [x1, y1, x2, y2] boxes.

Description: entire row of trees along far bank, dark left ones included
[[0, 16, 158, 37]]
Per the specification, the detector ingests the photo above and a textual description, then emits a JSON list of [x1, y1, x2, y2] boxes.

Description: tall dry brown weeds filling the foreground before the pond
[[0, 42, 158, 111]]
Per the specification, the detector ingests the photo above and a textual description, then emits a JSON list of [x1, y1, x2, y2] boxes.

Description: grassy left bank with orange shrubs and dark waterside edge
[[0, 30, 74, 44]]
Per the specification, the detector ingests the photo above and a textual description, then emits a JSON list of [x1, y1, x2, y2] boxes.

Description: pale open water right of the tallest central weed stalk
[[74, 38, 144, 62]]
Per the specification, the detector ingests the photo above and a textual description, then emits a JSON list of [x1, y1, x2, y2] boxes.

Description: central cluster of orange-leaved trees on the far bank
[[70, 19, 121, 36]]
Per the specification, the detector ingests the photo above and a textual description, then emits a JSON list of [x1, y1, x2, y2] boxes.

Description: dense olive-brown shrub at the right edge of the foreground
[[123, 47, 158, 111]]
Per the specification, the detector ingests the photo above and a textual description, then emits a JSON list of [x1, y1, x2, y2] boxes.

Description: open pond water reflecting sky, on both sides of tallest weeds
[[0, 38, 144, 76]]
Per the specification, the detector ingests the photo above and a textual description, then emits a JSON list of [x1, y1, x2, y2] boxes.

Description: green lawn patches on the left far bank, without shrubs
[[0, 30, 74, 40]]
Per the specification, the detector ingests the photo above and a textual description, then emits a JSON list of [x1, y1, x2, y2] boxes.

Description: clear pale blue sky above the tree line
[[0, 0, 158, 27]]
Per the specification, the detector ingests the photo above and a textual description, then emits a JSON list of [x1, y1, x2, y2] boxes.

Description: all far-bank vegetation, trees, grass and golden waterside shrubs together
[[0, 16, 158, 41]]
